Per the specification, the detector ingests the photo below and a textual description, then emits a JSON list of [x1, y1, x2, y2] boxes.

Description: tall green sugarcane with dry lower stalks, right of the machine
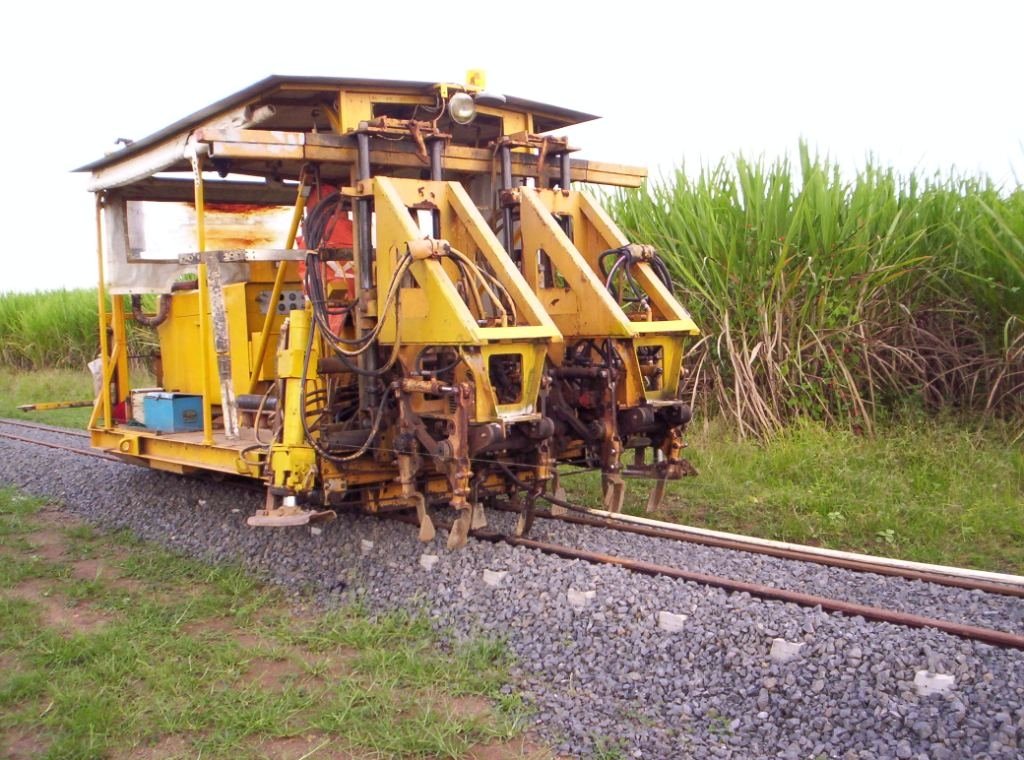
[[607, 144, 1024, 437]]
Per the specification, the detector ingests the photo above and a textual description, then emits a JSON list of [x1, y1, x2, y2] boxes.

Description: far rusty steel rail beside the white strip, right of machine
[[520, 510, 1024, 598]]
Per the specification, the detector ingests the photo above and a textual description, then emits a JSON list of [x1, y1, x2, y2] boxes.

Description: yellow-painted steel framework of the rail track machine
[[89, 77, 698, 512]]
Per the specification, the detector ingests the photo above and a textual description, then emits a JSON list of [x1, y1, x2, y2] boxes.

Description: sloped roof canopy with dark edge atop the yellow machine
[[76, 76, 646, 194]]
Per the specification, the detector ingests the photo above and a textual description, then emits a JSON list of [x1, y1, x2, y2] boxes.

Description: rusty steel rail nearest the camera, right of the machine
[[470, 531, 1024, 649]]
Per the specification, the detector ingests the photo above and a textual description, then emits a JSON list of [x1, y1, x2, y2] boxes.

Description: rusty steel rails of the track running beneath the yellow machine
[[0, 419, 1024, 649]]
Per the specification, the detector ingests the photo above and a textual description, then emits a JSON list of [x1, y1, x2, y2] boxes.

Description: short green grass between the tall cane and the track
[[563, 415, 1024, 574]]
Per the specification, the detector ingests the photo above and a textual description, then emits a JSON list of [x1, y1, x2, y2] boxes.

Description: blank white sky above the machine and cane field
[[0, 0, 1024, 291]]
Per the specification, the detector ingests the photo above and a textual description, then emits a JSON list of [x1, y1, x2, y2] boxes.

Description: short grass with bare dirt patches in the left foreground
[[0, 490, 522, 758]]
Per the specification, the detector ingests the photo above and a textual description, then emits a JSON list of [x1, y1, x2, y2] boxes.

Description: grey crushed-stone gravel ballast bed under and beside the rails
[[0, 427, 1024, 760]]
